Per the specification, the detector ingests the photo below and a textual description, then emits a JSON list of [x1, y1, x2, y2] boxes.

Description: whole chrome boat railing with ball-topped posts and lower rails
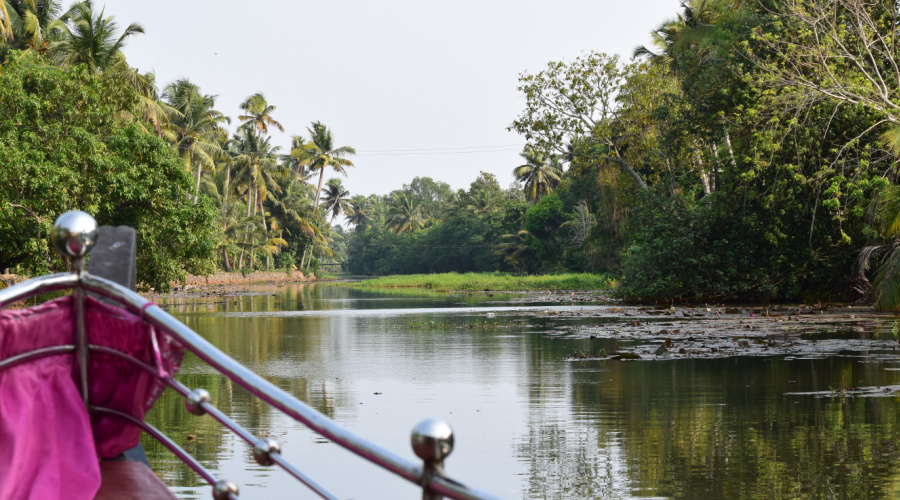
[[0, 212, 498, 500]]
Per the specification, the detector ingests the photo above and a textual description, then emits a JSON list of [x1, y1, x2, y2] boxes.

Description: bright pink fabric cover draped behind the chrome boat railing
[[0, 297, 183, 500]]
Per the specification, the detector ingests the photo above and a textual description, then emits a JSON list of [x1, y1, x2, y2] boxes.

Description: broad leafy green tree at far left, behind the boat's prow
[[0, 57, 216, 288]]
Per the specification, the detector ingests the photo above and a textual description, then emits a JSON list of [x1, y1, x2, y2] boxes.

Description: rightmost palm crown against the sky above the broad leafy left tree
[[50, 0, 144, 71]]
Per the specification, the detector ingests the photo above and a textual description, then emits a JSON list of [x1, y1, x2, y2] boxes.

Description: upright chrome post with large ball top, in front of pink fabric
[[50, 210, 100, 405]]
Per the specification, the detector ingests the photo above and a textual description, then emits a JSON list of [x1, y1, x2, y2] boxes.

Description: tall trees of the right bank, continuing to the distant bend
[[348, 0, 900, 308]]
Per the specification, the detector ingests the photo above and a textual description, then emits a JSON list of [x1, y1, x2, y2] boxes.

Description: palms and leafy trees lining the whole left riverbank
[[0, 0, 353, 290]]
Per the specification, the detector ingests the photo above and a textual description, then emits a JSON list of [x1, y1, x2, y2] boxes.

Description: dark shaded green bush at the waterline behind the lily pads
[[617, 189, 853, 303]]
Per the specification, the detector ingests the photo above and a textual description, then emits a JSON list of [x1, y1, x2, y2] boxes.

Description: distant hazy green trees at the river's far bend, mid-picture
[[346, 174, 526, 275]]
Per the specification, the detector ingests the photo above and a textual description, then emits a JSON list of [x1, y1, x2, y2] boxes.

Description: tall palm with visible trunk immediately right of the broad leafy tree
[[163, 79, 228, 203]]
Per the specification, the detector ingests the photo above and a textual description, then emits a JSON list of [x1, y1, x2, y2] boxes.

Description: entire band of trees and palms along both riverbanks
[[0, 0, 900, 309]]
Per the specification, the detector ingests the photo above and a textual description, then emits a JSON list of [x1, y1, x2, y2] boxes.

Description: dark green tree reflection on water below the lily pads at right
[[517, 358, 900, 498]]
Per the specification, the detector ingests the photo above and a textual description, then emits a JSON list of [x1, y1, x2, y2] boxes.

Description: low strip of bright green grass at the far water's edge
[[358, 273, 615, 291]]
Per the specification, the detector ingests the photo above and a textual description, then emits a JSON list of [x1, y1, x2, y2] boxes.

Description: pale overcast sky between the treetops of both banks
[[95, 0, 679, 195]]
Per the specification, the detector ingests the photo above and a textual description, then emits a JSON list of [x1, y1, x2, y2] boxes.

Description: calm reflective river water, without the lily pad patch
[[144, 284, 900, 500]]
